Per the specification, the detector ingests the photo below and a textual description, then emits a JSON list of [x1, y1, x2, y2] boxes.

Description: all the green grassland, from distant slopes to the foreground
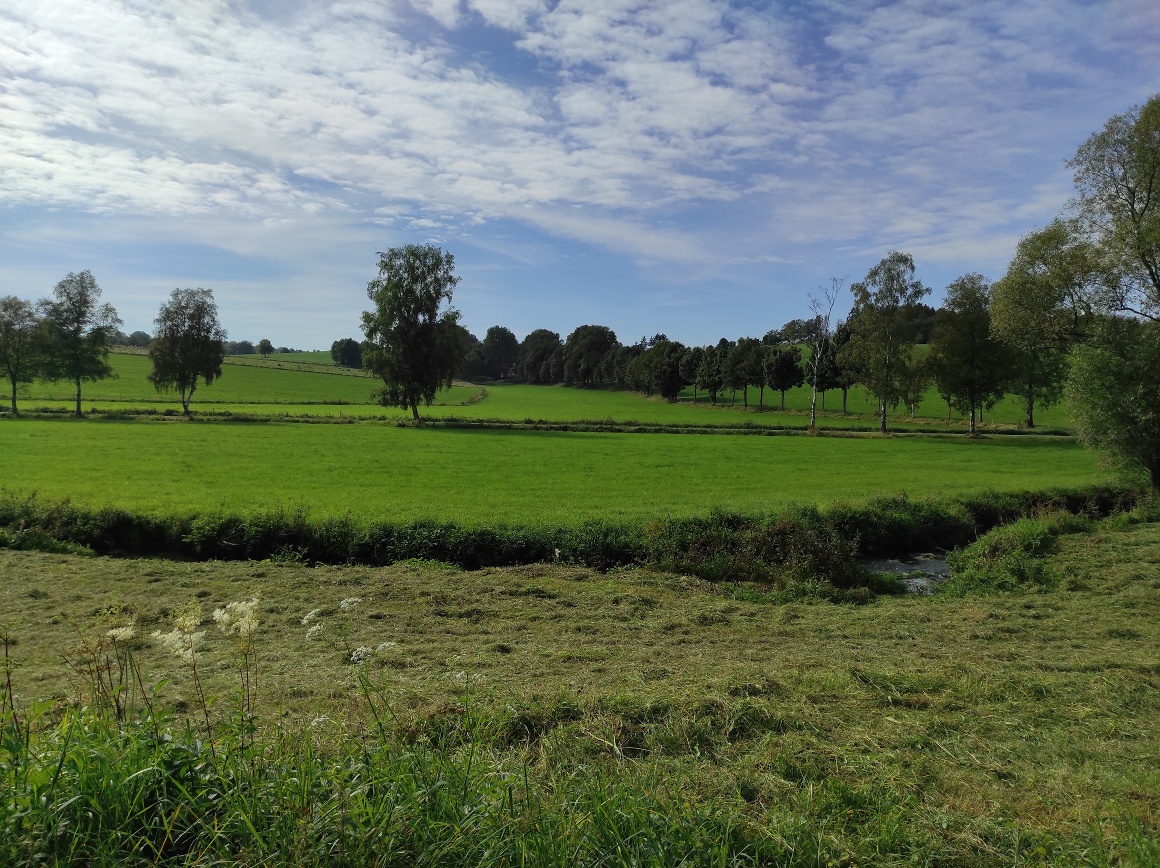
[[0, 354, 1160, 866]]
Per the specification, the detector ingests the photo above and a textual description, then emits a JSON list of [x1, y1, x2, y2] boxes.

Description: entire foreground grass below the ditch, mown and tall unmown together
[[0, 512, 1160, 866]]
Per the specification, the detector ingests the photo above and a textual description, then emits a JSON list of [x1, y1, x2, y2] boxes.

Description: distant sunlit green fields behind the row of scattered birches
[[13, 353, 1070, 429]]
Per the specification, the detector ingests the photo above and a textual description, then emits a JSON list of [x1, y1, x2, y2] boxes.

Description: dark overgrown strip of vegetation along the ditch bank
[[0, 486, 1146, 588]]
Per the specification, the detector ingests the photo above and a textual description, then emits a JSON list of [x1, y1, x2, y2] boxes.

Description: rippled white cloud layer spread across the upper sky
[[0, 0, 1160, 341]]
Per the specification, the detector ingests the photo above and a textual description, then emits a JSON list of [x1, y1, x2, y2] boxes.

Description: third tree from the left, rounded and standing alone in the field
[[148, 288, 225, 417]]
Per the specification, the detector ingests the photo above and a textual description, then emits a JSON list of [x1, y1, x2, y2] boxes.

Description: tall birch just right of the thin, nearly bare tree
[[839, 251, 930, 434]]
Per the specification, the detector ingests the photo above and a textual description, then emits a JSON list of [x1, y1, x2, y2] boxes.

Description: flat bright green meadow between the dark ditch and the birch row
[[0, 419, 1105, 523]]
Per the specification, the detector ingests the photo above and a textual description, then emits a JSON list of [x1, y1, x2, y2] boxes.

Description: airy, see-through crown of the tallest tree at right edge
[[1067, 94, 1160, 321]]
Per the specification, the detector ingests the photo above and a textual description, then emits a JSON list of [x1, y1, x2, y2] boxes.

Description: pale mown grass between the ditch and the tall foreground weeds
[[0, 515, 1160, 865]]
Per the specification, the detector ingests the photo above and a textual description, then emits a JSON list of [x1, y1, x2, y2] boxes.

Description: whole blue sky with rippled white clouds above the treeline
[[0, 0, 1160, 349]]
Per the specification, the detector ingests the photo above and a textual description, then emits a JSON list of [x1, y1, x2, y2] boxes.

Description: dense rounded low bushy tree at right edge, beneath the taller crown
[[1067, 317, 1160, 494]]
